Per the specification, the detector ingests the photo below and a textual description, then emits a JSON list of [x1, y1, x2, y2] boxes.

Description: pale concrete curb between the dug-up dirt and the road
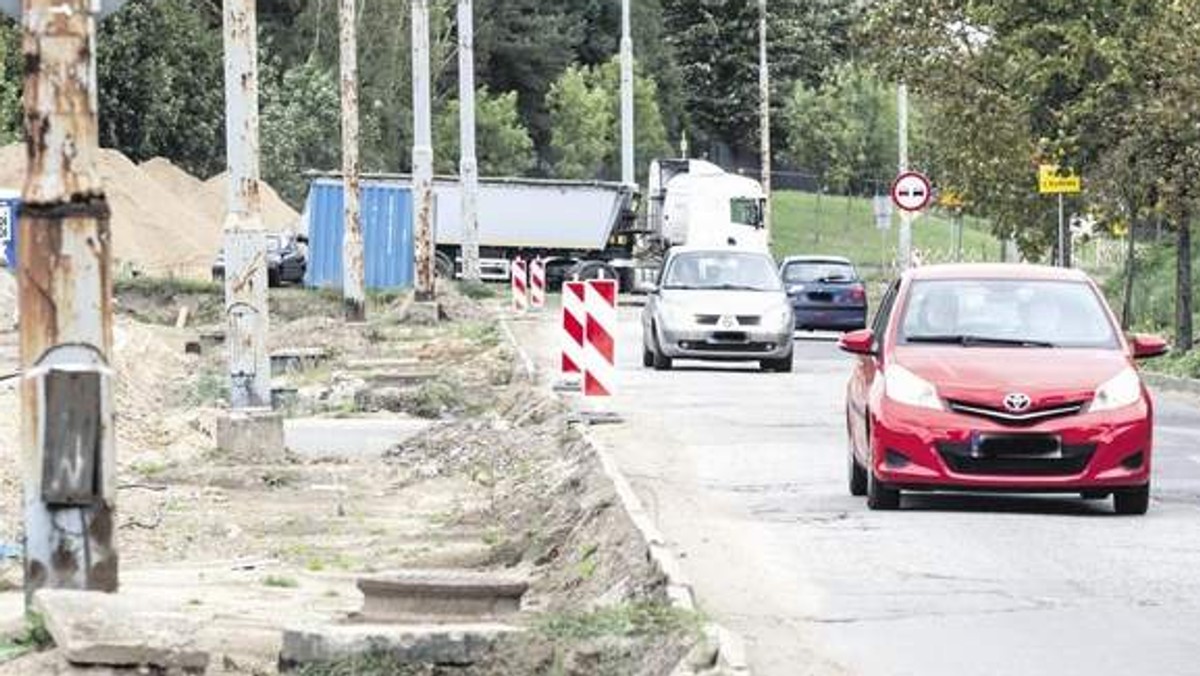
[[499, 317, 750, 676]]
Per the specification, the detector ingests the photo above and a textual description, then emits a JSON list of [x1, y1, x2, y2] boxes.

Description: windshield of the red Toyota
[[899, 280, 1117, 348]]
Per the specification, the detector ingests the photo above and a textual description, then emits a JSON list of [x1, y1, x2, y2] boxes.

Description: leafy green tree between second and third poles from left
[[260, 60, 342, 205]]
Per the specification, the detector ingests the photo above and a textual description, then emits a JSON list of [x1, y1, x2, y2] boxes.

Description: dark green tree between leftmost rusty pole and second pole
[[97, 0, 224, 175]]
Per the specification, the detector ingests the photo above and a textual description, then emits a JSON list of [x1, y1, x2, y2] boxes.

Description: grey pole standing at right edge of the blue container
[[412, 0, 434, 301]]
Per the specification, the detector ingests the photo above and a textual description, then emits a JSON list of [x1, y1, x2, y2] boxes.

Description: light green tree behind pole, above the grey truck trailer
[[433, 88, 535, 177]]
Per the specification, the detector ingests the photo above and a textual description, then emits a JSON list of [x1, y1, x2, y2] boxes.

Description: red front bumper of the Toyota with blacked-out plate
[[871, 399, 1153, 492]]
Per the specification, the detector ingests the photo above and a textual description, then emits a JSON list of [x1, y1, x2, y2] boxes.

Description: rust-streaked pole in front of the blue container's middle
[[338, 0, 367, 322]]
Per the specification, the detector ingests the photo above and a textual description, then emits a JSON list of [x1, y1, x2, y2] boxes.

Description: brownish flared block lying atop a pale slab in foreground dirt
[[358, 570, 529, 622]]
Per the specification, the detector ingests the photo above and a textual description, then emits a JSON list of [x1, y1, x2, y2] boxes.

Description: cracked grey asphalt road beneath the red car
[[516, 309, 1200, 676]]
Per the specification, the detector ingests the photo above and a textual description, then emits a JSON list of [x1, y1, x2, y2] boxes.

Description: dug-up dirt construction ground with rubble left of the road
[[0, 283, 742, 676]]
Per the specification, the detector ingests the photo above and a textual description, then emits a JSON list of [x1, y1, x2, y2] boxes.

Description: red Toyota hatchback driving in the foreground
[[840, 264, 1166, 514]]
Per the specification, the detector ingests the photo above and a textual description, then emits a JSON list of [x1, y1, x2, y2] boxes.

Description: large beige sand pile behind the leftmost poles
[[0, 144, 299, 277]]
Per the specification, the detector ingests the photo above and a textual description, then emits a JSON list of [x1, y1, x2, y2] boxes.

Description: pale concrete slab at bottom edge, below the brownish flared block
[[280, 623, 522, 672]]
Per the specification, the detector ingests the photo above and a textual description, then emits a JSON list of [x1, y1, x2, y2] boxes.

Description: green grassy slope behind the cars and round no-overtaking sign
[[772, 191, 1000, 268]]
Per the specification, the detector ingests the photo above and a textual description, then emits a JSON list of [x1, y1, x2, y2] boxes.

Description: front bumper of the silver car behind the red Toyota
[[658, 327, 792, 361]]
